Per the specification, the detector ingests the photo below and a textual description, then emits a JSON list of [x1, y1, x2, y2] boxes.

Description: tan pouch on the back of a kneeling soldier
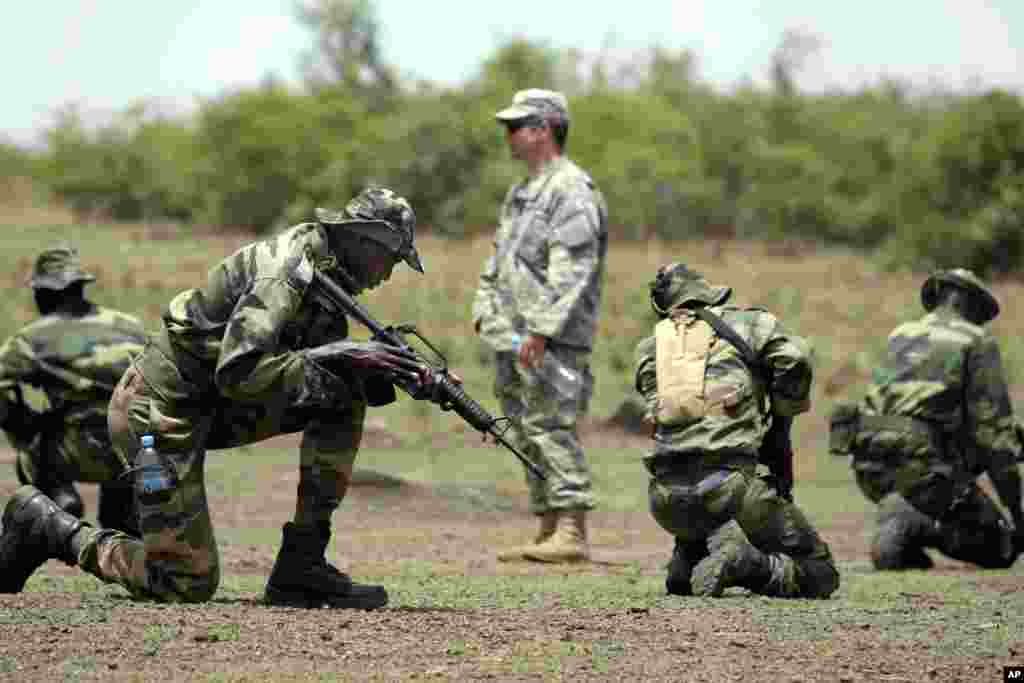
[[654, 311, 716, 427]]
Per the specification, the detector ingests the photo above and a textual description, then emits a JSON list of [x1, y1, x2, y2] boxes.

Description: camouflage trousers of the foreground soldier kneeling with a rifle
[[73, 358, 366, 602]]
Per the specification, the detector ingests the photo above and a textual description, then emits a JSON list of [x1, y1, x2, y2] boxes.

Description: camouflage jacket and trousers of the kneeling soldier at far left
[[0, 305, 147, 484]]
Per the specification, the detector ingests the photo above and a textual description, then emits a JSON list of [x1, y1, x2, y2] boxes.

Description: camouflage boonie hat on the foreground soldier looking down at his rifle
[[316, 187, 423, 272]]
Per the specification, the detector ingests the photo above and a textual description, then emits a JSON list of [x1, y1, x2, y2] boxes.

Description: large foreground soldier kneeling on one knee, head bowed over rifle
[[0, 188, 429, 609]]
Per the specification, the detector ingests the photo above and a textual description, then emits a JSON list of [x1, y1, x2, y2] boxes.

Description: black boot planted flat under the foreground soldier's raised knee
[[264, 522, 387, 609]]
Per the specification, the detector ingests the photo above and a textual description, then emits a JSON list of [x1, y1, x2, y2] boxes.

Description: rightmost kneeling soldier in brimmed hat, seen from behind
[[833, 268, 1024, 569]]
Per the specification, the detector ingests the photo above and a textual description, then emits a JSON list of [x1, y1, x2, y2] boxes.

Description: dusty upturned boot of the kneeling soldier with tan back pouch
[[690, 520, 772, 598]]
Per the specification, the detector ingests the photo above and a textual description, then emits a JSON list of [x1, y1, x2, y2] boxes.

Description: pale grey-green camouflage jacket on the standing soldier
[[473, 157, 608, 351]]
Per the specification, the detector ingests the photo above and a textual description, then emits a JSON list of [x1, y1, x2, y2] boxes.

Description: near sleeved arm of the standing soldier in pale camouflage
[[522, 188, 603, 338]]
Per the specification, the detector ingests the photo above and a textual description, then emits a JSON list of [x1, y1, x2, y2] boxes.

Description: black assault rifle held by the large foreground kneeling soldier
[[313, 271, 547, 479]]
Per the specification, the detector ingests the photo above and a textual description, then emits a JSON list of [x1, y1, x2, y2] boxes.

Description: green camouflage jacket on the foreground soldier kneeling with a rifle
[[139, 223, 356, 417]]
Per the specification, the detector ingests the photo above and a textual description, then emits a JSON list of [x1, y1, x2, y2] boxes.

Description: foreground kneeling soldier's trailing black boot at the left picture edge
[[0, 485, 85, 593]]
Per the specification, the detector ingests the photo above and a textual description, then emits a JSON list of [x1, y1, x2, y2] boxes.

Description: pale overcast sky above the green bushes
[[0, 0, 1024, 143]]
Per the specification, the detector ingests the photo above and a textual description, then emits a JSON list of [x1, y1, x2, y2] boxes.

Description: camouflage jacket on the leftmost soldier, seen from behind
[[0, 304, 147, 438]]
